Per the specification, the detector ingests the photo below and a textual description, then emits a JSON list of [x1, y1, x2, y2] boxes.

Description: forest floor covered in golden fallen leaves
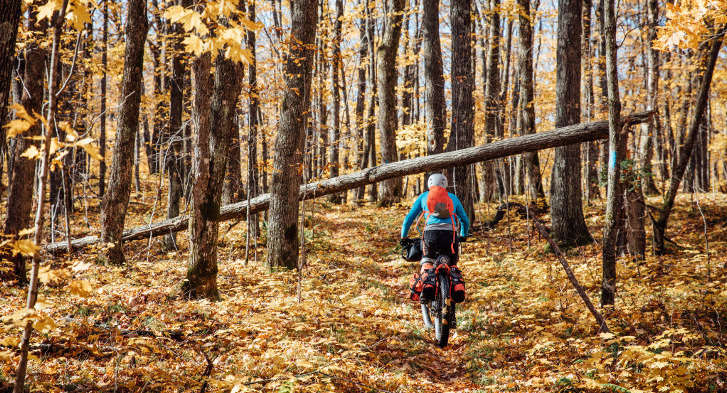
[[0, 185, 727, 392]]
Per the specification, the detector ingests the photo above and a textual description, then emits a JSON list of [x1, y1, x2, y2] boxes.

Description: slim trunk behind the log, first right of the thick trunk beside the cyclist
[[482, 0, 501, 202]]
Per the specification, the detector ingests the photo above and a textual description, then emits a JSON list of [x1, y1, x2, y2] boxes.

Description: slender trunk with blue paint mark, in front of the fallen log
[[601, 0, 626, 306]]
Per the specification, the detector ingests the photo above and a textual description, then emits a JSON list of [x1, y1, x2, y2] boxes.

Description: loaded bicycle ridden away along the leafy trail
[[421, 238, 465, 348]]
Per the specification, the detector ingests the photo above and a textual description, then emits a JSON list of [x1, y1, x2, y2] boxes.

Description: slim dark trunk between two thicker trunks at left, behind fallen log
[[163, 0, 190, 250]]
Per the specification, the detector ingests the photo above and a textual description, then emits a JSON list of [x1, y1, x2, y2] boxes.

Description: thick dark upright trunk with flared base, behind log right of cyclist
[[550, 0, 593, 247]]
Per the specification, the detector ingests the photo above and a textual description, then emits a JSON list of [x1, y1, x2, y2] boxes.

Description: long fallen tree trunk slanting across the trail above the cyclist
[[51, 112, 652, 253]]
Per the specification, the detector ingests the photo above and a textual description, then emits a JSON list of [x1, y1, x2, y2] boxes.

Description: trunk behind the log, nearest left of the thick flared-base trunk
[[518, 0, 545, 200]]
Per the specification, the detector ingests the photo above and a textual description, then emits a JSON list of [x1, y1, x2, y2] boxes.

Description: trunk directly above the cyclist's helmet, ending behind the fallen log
[[422, 0, 447, 154]]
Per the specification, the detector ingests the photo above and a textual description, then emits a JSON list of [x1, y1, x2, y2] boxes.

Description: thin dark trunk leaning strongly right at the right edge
[[652, 26, 727, 255]]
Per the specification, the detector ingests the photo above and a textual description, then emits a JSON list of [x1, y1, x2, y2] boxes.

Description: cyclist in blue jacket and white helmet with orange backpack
[[401, 173, 470, 302]]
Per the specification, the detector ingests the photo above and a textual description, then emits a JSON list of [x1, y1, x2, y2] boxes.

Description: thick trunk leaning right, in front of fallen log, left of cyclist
[[268, 0, 318, 269]]
